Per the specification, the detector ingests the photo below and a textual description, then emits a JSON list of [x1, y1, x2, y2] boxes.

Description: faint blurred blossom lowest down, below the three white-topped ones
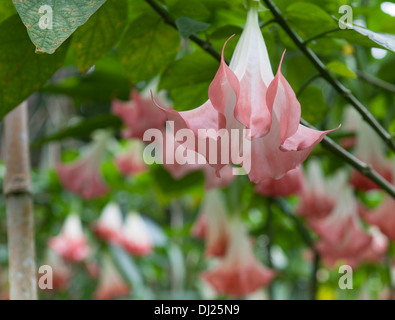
[[94, 256, 130, 300]]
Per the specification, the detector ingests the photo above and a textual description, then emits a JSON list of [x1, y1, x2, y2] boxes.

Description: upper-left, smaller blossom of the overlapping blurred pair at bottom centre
[[192, 189, 229, 257]]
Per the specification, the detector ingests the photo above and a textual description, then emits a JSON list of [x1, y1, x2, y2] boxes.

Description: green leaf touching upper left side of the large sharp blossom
[[159, 52, 219, 110]]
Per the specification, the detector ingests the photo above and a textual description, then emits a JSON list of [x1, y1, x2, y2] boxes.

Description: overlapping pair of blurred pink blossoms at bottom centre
[[193, 190, 274, 297]]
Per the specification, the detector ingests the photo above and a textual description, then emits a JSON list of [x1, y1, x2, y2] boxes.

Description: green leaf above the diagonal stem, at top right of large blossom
[[284, 2, 336, 36]]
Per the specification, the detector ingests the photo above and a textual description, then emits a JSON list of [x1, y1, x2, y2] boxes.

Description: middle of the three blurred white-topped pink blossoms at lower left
[[93, 202, 123, 244]]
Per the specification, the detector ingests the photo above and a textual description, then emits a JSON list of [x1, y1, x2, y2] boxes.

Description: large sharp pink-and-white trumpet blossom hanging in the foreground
[[153, 8, 338, 183]]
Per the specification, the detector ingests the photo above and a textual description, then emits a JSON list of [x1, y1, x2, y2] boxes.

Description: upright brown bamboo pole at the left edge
[[4, 102, 37, 300]]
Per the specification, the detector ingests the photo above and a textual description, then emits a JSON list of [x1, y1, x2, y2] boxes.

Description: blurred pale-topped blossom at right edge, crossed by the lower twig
[[351, 111, 395, 191]]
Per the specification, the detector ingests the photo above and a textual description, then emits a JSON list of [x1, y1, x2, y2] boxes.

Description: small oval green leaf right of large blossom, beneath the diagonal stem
[[298, 86, 328, 124]]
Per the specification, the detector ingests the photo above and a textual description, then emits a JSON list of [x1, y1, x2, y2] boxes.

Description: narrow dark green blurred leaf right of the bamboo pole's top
[[32, 114, 122, 147]]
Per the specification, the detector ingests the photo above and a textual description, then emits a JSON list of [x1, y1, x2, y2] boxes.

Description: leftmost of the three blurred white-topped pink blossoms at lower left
[[48, 214, 90, 262]]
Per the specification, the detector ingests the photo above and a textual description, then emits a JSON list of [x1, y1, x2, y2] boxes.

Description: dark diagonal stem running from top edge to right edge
[[263, 0, 395, 151]]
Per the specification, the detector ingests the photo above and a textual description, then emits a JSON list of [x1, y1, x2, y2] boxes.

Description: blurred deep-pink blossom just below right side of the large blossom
[[255, 167, 304, 197]]
